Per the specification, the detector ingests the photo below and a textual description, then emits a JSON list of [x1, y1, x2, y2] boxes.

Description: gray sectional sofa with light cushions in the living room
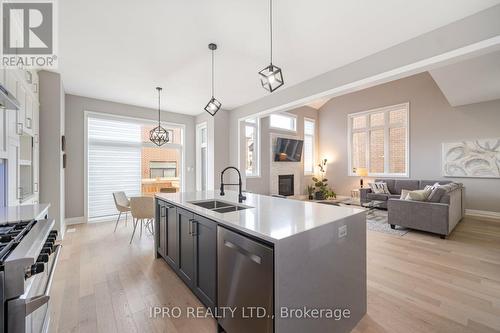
[[360, 179, 465, 238]]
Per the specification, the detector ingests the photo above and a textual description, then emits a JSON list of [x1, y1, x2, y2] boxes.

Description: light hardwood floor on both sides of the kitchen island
[[50, 218, 500, 333]]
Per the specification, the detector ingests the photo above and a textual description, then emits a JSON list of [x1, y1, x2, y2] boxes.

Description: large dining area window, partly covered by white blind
[[86, 113, 184, 220]]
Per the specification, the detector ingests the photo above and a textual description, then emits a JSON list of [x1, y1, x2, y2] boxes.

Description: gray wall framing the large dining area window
[[66, 94, 195, 217]]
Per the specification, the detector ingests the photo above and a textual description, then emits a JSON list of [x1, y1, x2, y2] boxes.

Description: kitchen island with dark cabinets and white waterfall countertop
[[155, 191, 366, 333]]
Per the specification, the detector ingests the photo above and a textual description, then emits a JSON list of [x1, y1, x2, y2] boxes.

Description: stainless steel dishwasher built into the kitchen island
[[217, 227, 274, 333]]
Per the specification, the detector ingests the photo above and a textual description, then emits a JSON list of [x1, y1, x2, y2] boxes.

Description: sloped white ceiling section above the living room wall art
[[429, 52, 500, 106]]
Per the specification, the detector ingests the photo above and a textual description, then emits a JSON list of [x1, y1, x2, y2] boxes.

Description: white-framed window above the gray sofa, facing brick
[[348, 103, 409, 177]]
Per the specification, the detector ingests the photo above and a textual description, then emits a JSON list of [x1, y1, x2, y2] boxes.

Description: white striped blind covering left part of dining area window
[[87, 117, 141, 219]]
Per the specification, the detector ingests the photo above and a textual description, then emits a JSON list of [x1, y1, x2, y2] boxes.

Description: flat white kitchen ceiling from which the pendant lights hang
[[58, 0, 500, 115]]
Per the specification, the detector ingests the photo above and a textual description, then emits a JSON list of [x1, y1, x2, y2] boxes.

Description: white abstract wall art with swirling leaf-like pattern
[[442, 138, 500, 178]]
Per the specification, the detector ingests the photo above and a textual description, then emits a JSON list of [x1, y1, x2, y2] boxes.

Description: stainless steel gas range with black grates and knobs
[[0, 219, 61, 333]]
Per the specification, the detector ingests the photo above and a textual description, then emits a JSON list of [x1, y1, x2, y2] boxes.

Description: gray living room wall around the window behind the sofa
[[319, 72, 500, 212]]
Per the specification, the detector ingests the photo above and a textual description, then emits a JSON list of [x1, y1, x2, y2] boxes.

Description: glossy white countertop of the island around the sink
[[156, 191, 364, 243]]
